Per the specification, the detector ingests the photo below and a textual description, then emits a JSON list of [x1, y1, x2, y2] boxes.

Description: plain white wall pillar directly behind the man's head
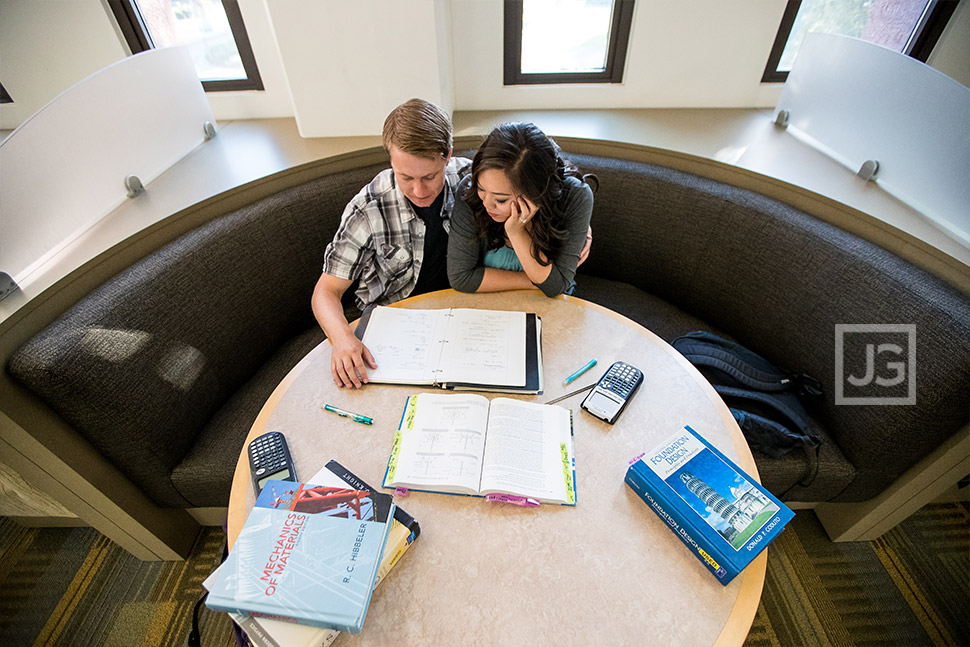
[[266, 0, 452, 137]]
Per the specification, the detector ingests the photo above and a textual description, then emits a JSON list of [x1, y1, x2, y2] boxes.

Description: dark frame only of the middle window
[[503, 0, 635, 85]]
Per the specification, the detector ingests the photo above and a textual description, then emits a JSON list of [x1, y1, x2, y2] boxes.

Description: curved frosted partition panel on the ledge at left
[[0, 47, 215, 284]]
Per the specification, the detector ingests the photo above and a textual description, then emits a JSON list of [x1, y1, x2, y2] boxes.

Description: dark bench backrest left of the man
[[9, 164, 385, 507]]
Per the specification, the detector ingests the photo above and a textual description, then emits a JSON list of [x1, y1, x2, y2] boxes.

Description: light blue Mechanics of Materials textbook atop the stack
[[206, 480, 395, 633]]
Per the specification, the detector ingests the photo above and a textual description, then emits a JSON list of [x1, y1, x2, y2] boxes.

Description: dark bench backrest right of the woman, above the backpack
[[571, 155, 970, 501]]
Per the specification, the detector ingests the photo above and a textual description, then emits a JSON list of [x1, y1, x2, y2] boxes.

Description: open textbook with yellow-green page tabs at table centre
[[384, 393, 576, 506]]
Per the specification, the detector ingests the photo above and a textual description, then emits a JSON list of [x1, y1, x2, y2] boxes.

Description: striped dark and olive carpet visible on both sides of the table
[[0, 503, 970, 647]]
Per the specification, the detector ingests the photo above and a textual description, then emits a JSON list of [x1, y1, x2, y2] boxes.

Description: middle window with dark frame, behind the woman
[[505, 0, 634, 85]]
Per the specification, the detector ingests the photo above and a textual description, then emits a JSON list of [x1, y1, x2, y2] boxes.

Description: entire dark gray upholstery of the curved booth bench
[[8, 148, 970, 507]]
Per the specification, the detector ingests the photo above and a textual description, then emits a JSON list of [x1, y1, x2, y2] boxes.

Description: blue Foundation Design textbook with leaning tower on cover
[[625, 427, 795, 585]]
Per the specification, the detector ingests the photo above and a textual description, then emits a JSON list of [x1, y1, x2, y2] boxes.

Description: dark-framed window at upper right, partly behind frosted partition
[[761, 0, 957, 83]]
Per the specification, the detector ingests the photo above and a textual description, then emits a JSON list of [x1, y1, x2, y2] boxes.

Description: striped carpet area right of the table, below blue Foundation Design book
[[745, 504, 970, 647]]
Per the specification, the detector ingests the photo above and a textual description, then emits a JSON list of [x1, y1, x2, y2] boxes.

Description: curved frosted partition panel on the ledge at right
[[777, 33, 970, 245]]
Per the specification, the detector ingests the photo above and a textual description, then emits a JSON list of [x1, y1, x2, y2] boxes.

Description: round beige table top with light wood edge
[[228, 290, 767, 647]]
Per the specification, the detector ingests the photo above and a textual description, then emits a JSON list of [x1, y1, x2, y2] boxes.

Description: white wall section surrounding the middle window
[[452, 0, 785, 110]]
